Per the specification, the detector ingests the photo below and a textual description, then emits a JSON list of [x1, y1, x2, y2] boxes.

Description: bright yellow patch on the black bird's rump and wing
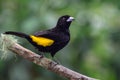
[[30, 35, 54, 47]]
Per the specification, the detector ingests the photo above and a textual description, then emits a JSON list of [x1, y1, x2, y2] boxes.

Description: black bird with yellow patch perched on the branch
[[4, 15, 74, 57]]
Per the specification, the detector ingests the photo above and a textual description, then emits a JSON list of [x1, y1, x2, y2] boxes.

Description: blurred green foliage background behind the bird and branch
[[0, 0, 120, 80]]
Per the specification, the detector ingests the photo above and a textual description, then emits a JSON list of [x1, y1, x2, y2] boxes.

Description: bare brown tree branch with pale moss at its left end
[[2, 35, 97, 80]]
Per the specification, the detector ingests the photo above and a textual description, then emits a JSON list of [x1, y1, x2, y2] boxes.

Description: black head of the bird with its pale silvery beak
[[56, 15, 74, 28]]
